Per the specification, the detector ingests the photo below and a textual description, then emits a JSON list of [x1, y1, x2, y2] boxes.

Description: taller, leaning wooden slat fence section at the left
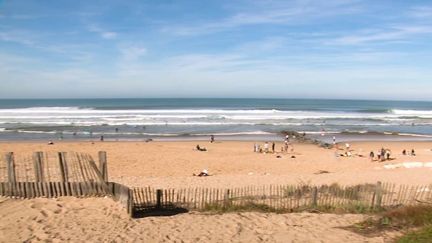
[[0, 151, 133, 213]]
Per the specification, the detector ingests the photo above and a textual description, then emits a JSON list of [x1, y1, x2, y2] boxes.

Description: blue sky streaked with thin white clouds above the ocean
[[0, 0, 432, 100]]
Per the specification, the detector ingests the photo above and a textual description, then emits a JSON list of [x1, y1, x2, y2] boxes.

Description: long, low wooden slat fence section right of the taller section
[[131, 182, 432, 211]]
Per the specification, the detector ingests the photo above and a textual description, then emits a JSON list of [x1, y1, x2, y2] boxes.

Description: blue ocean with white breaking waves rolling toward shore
[[0, 99, 432, 141]]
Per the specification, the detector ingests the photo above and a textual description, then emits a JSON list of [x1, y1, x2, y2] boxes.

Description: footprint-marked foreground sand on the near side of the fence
[[0, 197, 394, 242]]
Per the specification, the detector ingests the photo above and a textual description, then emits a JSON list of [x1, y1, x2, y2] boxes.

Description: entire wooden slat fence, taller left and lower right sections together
[[0, 151, 432, 216]]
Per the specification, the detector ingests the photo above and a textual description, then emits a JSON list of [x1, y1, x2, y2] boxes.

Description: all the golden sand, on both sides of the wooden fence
[[0, 141, 432, 242]]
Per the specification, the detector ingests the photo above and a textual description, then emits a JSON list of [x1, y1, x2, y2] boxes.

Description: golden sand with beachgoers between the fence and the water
[[0, 141, 432, 188]]
